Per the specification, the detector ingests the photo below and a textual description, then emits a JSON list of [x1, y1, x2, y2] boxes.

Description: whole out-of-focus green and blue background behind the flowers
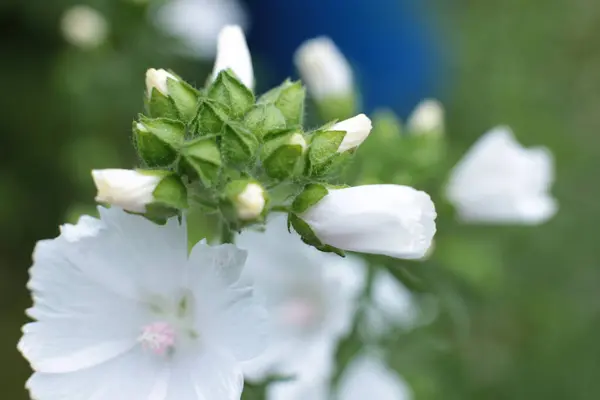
[[0, 0, 600, 400]]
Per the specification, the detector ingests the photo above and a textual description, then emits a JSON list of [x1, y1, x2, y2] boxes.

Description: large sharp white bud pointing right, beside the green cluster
[[300, 185, 436, 259]]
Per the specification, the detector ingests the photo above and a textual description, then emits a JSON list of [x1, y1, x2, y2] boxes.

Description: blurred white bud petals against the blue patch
[[295, 37, 354, 100]]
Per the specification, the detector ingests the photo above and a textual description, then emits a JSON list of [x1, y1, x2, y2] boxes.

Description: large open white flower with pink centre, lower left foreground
[[18, 208, 264, 400]]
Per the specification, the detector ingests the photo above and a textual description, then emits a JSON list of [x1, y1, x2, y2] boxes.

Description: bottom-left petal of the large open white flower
[[27, 347, 169, 400]]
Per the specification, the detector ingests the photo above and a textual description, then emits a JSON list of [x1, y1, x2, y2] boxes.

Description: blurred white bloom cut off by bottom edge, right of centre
[[337, 355, 412, 400]]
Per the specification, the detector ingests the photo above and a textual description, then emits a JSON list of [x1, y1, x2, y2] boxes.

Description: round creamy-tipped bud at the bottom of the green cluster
[[222, 180, 267, 222]]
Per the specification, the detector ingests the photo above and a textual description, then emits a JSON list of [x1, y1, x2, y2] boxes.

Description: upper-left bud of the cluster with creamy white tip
[[146, 68, 198, 122]]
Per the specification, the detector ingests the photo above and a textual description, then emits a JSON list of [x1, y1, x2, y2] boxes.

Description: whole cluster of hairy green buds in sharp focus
[[133, 70, 354, 230]]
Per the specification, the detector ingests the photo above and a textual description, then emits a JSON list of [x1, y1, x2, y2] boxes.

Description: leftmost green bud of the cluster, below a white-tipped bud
[[133, 117, 185, 167]]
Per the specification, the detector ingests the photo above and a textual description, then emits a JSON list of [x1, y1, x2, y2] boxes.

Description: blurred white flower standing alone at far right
[[446, 127, 558, 224]]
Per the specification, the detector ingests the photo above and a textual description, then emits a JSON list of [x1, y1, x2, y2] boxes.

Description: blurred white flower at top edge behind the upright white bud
[[156, 0, 248, 59]]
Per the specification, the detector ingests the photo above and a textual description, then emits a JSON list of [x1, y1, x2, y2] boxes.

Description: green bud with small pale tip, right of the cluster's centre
[[261, 131, 306, 180]]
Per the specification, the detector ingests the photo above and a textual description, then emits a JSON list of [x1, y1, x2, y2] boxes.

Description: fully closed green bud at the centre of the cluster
[[221, 122, 259, 166]]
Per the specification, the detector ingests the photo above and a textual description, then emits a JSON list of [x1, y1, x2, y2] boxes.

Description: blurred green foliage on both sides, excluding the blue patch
[[0, 0, 600, 400]]
